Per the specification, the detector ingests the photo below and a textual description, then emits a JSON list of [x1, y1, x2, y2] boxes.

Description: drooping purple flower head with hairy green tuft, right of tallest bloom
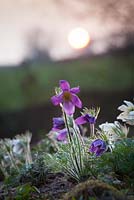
[[75, 108, 100, 125]]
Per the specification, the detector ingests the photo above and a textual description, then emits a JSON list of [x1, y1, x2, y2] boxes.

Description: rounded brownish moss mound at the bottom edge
[[63, 180, 127, 200]]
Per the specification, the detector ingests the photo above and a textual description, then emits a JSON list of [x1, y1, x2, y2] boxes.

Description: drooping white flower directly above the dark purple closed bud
[[99, 121, 129, 142]]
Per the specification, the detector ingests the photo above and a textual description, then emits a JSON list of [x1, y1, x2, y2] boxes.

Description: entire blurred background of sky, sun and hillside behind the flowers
[[0, 0, 134, 142]]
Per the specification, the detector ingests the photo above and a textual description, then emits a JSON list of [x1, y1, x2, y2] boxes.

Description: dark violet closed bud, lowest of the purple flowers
[[89, 139, 107, 156]]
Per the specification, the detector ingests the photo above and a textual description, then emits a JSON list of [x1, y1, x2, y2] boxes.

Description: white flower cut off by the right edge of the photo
[[117, 101, 134, 125]]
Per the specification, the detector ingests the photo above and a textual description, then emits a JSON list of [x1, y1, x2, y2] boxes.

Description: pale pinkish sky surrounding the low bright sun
[[0, 0, 134, 65]]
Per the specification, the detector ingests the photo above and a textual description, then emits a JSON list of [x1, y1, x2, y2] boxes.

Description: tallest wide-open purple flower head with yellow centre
[[51, 80, 82, 115]]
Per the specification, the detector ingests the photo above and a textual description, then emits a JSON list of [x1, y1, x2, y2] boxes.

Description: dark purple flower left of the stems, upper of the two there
[[52, 117, 65, 131]]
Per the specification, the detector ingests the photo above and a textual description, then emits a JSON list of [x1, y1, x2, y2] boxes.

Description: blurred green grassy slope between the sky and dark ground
[[0, 54, 134, 111]]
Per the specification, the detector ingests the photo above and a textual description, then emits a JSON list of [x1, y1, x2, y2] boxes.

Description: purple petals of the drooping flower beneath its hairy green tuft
[[75, 114, 96, 125]]
